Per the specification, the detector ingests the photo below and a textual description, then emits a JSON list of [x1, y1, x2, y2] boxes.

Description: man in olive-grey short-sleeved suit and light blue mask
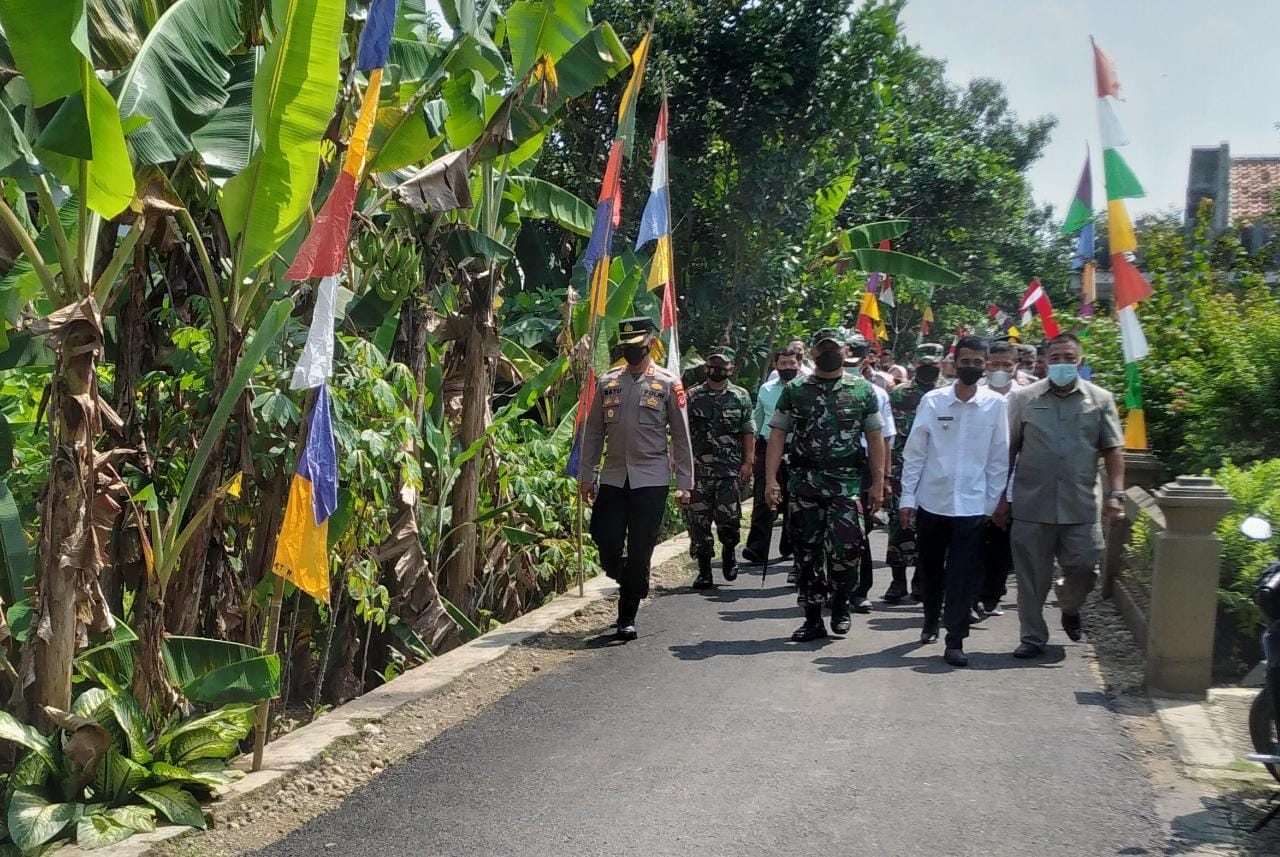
[[992, 334, 1124, 657]]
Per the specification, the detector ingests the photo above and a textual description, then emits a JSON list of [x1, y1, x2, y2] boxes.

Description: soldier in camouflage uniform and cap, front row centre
[[764, 327, 884, 642]]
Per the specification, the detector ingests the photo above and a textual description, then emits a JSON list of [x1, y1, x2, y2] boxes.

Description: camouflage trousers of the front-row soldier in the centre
[[787, 492, 863, 606]]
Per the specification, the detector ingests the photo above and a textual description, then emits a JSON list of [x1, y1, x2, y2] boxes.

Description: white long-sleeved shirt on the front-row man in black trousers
[[900, 385, 1009, 517]]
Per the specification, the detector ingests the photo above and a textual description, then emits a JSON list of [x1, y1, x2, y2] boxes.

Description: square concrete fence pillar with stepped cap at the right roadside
[[1147, 476, 1235, 697]]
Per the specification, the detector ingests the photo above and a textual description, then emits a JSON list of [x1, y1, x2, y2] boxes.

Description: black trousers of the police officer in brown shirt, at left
[[591, 482, 668, 625]]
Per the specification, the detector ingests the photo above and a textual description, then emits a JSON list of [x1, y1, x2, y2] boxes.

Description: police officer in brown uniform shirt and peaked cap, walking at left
[[577, 316, 694, 640]]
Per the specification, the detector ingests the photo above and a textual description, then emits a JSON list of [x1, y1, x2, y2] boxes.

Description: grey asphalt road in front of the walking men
[[260, 533, 1162, 857]]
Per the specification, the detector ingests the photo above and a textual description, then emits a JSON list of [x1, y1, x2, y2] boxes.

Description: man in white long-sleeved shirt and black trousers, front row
[[899, 336, 1009, 666]]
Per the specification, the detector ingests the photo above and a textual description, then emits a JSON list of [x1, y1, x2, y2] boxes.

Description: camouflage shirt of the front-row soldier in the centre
[[769, 375, 881, 494]]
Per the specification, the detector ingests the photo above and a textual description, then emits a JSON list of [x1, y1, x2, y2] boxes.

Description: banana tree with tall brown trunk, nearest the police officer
[[376, 0, 628, 619]]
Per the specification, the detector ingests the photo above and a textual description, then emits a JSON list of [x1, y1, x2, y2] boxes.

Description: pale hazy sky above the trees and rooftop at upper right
[[904, 0, 1280, 214]]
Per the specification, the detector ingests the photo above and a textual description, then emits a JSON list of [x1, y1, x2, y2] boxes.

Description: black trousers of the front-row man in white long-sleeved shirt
[[915, 509, 984, 649]]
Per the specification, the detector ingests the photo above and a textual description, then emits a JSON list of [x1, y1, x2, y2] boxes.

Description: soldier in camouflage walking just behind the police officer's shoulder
[[685, 348, 755, 590]]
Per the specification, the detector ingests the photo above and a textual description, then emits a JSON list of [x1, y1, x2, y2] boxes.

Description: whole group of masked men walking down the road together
[[579, 317, 1124, 666]]
